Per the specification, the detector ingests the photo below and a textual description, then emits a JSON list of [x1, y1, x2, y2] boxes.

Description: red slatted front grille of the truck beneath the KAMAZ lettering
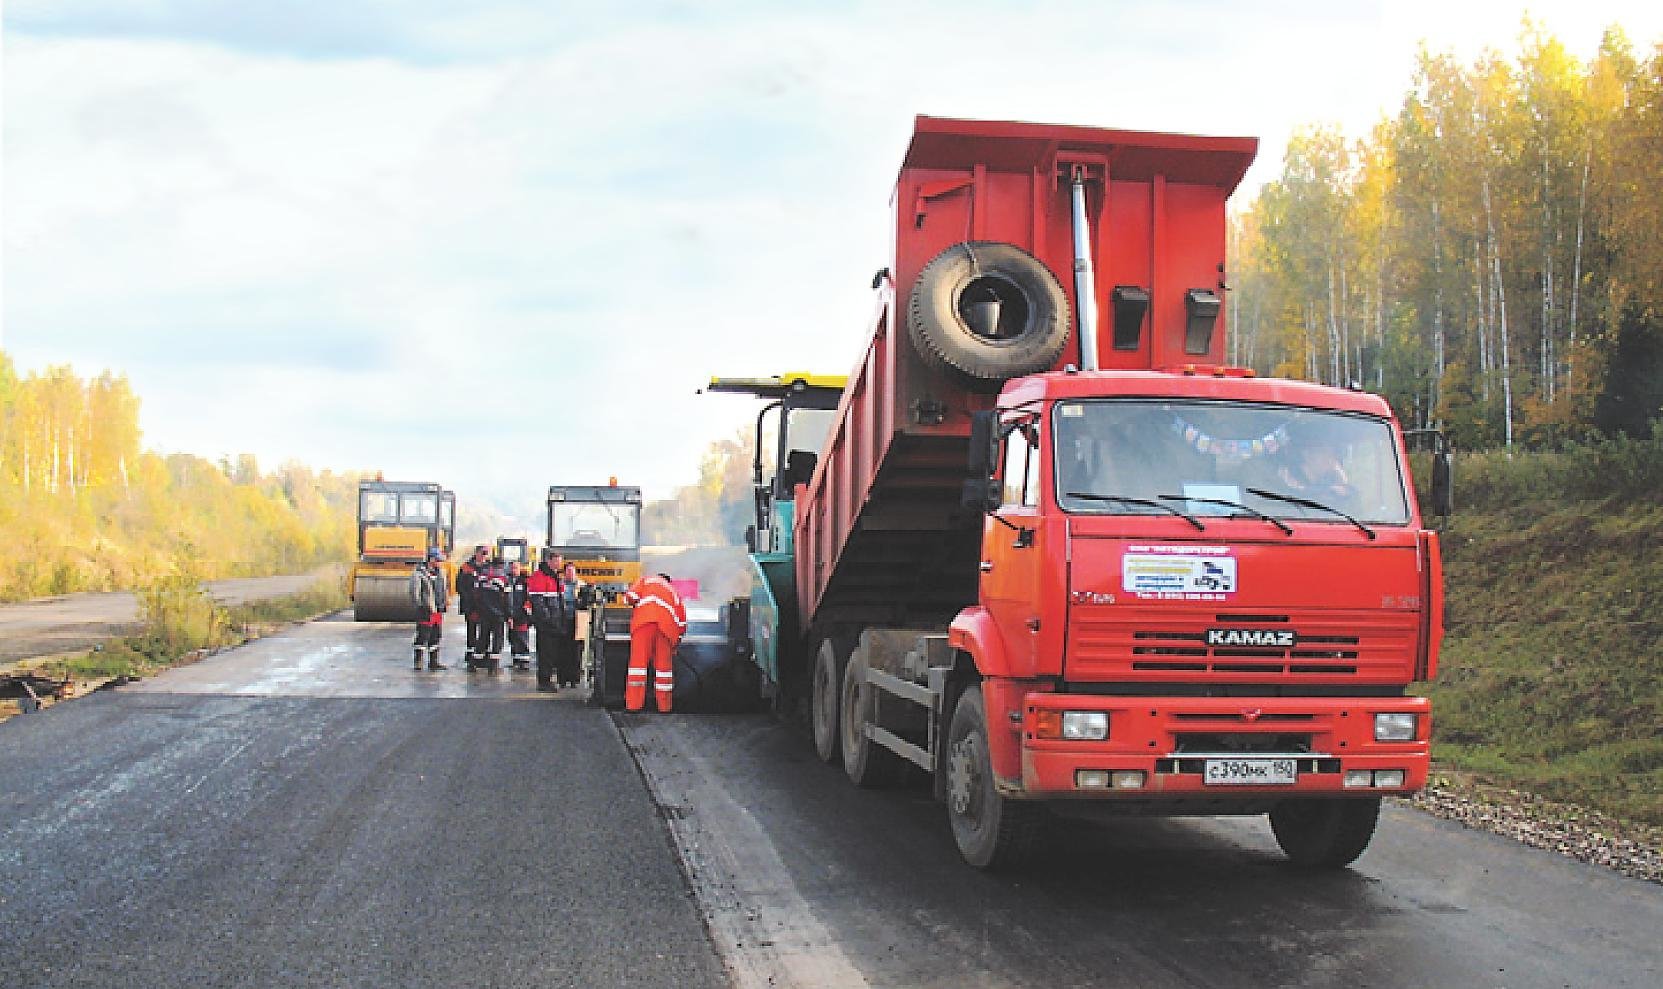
[[1068, 607, 1417, 681]]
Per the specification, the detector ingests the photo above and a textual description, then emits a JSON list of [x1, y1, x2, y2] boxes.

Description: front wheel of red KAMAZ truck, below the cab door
[[946, 686, 1044, 869]]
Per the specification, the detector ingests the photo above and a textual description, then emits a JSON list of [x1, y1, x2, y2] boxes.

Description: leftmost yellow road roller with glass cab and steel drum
[[346, 477, 456, 622]]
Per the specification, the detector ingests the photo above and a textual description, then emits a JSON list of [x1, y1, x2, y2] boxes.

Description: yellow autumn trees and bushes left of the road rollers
[[0, 351, 358, 600]]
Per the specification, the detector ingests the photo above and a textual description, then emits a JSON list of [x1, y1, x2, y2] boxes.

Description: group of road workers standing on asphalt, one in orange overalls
[[411, 545, 687, 711]]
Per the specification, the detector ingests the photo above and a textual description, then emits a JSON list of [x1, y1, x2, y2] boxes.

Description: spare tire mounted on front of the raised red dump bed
[[908, 241, 1069, 387]]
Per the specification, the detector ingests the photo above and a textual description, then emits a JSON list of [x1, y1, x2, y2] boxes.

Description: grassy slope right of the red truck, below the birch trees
[[1430, 440, 1663, 826]]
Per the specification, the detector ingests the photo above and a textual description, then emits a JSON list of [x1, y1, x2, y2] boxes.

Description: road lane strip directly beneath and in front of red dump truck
[[619, 715, 1663, 989]]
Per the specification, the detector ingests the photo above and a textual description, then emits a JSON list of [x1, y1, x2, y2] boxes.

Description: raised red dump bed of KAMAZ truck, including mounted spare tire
[[795, 116, 1257, 640]]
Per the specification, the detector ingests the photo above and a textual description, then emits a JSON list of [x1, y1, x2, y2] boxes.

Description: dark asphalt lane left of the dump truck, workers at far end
[[0, 620, 727, 989]]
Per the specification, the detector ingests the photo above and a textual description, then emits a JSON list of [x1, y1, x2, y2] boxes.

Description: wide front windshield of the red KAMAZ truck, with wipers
[[1053, 399, 1409, 525]]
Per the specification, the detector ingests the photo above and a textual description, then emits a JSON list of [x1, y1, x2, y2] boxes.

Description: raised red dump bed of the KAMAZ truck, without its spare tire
[[797, 116, 1257, 622]]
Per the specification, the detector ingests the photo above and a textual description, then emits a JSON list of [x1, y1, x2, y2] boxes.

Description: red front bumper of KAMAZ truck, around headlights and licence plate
[[1009, 693, 1432, 803]]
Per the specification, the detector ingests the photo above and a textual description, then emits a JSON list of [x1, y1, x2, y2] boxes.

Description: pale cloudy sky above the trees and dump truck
[[0, 0, 1663, 521]]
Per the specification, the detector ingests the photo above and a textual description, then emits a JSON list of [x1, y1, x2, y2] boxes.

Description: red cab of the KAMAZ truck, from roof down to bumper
[[948, 369, 1442, 844]]
